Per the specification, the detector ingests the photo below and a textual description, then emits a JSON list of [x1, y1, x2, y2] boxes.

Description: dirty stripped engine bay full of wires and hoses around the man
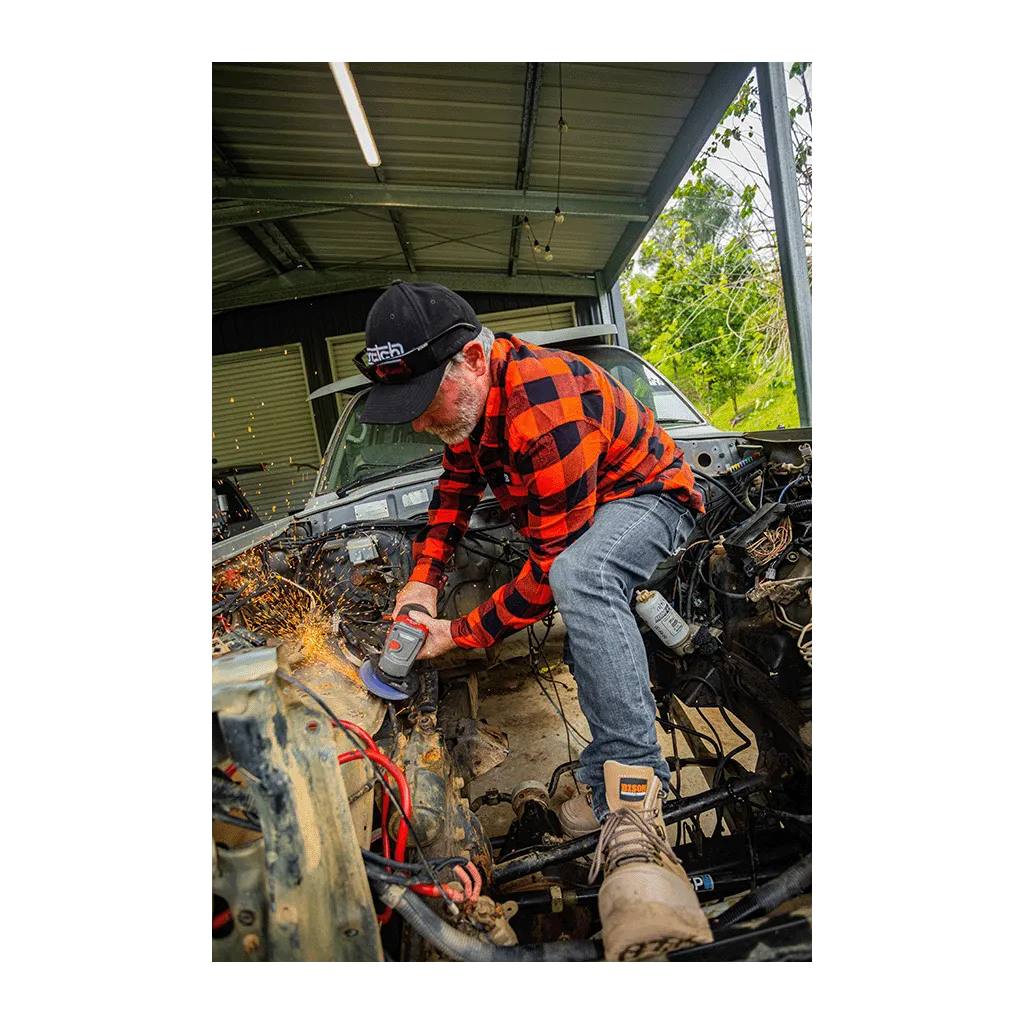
[[208, 430, 817, 967]]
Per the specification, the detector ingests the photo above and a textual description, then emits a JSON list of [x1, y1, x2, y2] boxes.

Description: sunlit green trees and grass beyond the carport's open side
[[624, 65, 811, 429]]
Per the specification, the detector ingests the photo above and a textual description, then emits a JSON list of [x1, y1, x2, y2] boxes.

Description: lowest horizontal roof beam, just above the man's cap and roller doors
[[210, 267, 597, 315]]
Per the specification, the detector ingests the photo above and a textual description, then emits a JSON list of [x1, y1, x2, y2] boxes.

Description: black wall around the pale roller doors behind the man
[[208, 288, 600, 451]]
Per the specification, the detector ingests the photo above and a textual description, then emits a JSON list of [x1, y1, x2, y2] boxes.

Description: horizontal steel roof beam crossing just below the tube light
[[213, 178, 651, 222]]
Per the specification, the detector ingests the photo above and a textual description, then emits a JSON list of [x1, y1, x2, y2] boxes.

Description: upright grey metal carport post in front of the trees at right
[[757, 60, 815, 427]]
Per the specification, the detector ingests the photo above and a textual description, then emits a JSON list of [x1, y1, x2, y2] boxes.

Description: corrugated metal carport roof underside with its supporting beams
[[210, 56, 753, 311]]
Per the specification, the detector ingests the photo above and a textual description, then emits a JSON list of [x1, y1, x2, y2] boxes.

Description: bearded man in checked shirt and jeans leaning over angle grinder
[[362, 283, 711, 961]]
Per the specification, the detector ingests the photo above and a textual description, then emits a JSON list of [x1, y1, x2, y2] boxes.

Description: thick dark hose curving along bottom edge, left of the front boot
[[374, 883, 600, 966]]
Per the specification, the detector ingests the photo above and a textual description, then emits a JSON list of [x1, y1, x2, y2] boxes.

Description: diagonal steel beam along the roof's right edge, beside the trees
[[604, 58, 754, 282]]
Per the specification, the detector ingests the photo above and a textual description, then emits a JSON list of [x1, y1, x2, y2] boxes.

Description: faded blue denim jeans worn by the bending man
[[548, 495, 694, 821]]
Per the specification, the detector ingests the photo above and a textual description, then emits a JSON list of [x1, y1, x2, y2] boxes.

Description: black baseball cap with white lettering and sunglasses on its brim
[[353, 281, 483, 423]]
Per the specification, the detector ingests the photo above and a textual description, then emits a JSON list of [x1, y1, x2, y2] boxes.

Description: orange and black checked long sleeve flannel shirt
[[410, 335, 703, 648]]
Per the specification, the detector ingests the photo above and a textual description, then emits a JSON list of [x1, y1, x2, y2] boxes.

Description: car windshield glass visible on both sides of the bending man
[[316, 345, 703, 495]]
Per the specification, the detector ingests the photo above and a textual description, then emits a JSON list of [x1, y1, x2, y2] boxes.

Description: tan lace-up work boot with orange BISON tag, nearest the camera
[[590, 761, 712, 961]]
